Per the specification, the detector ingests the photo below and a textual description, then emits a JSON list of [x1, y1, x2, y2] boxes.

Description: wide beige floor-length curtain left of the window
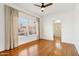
[[5, 5, 18, 50]]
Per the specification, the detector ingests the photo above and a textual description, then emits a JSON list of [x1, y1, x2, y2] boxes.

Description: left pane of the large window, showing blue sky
[[18, 16, 28, 35]]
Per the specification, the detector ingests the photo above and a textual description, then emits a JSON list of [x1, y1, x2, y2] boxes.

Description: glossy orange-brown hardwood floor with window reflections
[[0, 39, 78, 56]]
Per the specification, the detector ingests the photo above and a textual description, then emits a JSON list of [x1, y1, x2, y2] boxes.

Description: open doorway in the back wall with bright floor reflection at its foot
[[53, 20, 61, 48]]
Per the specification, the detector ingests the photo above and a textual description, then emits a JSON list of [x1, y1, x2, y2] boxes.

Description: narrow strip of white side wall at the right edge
[[73, 4, 79, 52]]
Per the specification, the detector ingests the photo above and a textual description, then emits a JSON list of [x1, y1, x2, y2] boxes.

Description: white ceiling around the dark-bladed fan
[[12, 3, 74, 16]]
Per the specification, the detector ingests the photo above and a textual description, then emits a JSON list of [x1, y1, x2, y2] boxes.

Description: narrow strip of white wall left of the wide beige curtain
[[0, 4, 5, 51]]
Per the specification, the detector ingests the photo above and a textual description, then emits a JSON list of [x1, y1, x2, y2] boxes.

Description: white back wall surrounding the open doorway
[[43, 11, 74, 43]]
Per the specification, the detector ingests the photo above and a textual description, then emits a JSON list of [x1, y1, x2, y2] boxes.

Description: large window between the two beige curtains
[[18, 13, 38, 36]]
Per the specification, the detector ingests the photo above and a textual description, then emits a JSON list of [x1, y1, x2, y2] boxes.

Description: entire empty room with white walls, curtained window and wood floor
[[0, 3, 79, 56]]
